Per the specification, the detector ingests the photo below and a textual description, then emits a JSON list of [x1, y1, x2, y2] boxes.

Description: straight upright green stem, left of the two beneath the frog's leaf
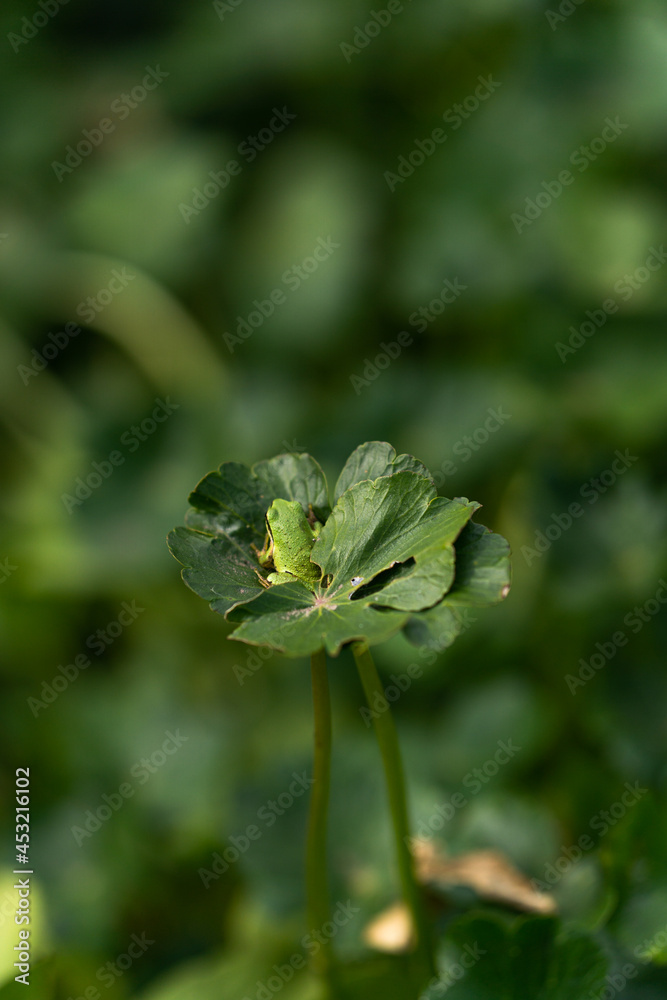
[[306, 649, 333, 992]]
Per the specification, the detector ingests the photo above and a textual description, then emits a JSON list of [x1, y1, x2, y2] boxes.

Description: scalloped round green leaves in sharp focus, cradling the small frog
[[169, 441, 509, 656]]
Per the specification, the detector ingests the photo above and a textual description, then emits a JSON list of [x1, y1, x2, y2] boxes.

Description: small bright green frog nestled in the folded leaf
[[257, 500, 322, 589]]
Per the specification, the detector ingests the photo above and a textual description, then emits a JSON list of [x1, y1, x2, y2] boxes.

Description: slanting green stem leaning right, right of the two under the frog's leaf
[[352, 642, 437, 976]]
